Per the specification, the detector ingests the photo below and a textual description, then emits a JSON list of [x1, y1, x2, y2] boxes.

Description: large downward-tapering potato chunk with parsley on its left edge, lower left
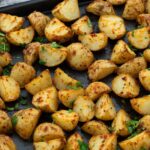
[[12, 108, 41, 140]]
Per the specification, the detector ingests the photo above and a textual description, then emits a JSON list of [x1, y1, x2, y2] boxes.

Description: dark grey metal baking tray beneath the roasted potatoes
[[0, 0, 148, 150]]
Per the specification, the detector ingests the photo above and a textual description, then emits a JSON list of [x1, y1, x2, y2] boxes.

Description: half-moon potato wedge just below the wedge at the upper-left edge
[[6, 26, 34, 46]]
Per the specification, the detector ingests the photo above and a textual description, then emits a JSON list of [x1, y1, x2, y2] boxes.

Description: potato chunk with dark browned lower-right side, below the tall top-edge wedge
[[45, 18, 73, 43]]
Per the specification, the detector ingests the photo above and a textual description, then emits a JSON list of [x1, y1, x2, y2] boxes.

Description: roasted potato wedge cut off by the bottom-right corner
[[119, 131, 150, 150]]
